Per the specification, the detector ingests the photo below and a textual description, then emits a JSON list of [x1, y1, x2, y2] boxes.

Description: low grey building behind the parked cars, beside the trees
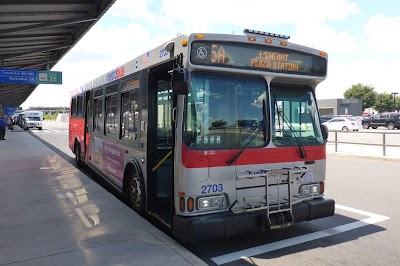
[[317, 99, 363, 116]]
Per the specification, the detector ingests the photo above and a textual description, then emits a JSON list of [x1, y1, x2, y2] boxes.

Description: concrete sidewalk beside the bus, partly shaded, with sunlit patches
[[0, 129, 207, 265]]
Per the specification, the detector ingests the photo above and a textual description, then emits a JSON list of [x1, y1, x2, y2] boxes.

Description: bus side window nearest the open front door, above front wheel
[[120, 91, 139, 142]]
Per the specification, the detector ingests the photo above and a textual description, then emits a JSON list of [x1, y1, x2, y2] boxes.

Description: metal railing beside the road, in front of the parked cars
[[328, 131, 400, 157]]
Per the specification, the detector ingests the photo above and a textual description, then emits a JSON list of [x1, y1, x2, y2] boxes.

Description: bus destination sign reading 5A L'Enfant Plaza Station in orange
[[190, 42, 326, 77]]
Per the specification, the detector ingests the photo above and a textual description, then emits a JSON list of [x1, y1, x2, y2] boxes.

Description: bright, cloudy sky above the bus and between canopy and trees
[[22, 0, 400, 109]]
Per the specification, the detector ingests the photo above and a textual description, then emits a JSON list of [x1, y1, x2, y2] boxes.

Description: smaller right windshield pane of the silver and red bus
[[271, 83, 324, 146]]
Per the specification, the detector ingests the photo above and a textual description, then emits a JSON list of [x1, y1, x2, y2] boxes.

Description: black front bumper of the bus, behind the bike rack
[[172, 198, 335, 242]]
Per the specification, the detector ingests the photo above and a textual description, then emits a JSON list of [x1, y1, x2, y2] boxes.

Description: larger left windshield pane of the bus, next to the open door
[[183, 73, 267, 150]]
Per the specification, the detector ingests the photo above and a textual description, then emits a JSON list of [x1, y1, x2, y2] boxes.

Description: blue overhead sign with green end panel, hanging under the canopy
[[0, 68, 62, 84]]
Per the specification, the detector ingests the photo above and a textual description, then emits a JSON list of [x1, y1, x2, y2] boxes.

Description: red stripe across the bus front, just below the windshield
[[182, 145, 326, 168]]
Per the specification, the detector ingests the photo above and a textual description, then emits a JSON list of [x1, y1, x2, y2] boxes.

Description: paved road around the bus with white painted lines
[[31, 122, 400, 266]]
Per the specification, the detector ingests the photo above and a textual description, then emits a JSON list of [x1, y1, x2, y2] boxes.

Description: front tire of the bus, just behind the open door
[[124, 170, 146, 215]]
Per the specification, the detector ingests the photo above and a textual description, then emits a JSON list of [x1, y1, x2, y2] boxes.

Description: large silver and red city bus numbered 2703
[[69, 29, 335, 243]]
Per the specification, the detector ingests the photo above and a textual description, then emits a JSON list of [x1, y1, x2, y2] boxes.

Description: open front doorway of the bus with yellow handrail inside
[[147, 65, 174, 224]]
